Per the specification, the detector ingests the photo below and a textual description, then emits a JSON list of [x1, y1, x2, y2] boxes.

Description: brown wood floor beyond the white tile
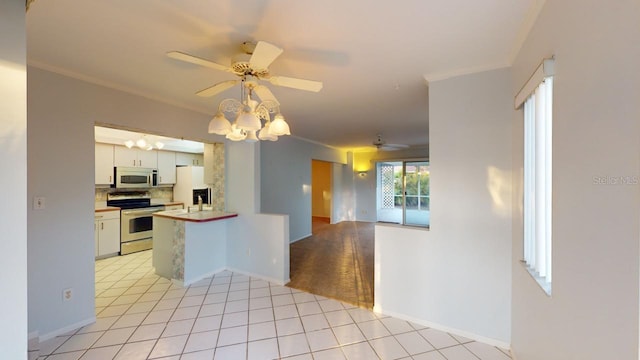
[[287, 218, 374, 309]]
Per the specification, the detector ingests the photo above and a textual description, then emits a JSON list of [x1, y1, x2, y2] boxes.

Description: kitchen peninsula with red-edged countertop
[[153, 209, 238, 286]]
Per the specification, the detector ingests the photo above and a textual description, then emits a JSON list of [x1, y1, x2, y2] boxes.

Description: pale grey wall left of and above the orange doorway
[[260, 136, 347, 241]]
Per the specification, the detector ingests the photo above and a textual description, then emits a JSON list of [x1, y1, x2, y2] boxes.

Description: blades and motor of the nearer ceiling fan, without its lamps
[[167, 41, 322, 104]]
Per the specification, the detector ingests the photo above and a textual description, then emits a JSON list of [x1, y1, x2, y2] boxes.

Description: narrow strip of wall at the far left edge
[[0, 1, 28, 359]]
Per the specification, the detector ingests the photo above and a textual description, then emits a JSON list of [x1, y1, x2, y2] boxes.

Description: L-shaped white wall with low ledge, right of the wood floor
[[374, 69, 513, 346]]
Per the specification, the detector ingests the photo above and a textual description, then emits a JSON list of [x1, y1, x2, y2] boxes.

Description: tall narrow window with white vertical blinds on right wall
[[516, 58, 553, 295]]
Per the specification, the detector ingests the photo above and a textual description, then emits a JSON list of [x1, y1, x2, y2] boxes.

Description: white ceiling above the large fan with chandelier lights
[[27, 0, 544, 148]]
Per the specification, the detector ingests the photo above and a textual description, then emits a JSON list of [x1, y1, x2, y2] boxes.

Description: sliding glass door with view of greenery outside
[[376, 160, 431, 227]]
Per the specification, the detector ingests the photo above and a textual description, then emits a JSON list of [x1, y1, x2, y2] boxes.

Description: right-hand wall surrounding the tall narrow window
[[510, 0, 640, 360]]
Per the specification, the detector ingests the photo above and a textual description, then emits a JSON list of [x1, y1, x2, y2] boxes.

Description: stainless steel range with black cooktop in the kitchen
[[107, 191, 164, 255]]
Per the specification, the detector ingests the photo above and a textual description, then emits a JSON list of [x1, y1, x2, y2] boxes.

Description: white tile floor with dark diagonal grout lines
[[38, 251, 510, 360]]
